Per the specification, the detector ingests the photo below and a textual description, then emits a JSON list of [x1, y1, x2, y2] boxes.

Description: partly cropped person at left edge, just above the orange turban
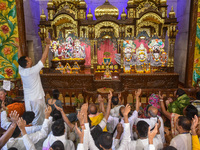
[[0, 88, 13, 108]]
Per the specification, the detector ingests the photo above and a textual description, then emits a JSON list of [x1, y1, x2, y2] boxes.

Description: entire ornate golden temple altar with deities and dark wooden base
[[39, 0, 179, 96]]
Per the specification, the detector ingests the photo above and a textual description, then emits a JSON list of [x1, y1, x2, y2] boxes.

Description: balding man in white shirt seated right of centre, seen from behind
[[136, 106, 165, 143]]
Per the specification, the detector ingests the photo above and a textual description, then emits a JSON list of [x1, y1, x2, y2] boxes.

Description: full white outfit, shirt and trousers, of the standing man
[[19, 60, 46, 125]]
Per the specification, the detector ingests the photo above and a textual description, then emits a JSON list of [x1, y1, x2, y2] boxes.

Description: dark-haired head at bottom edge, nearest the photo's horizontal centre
[[96, 132, 113, 149]]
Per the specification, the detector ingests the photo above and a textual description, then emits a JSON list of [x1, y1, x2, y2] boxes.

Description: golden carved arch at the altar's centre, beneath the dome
[[95, 21, 119, 38]]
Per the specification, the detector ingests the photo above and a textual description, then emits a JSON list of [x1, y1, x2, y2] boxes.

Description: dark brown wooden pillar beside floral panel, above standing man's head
[[16, 0, 28, 56]]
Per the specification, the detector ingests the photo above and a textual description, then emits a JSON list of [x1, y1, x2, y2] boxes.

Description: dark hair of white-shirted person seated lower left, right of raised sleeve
[[51, 119, 65, 136]]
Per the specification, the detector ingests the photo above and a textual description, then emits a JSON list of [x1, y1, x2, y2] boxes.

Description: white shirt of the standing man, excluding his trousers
[[19, 60, 45, 101]]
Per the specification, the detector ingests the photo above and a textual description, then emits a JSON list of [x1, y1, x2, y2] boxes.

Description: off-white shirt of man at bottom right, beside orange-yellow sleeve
[[170, 133, 192, 150]]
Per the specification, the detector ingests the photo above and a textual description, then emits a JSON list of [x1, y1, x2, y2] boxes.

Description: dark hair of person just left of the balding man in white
[[136, 120, 149, 137]]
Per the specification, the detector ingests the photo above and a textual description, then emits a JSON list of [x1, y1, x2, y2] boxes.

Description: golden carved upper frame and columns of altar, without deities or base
[[39, 0, 178, 72]]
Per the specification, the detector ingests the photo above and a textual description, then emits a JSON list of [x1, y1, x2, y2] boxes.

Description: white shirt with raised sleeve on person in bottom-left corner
[[2, 119, 49, 150]]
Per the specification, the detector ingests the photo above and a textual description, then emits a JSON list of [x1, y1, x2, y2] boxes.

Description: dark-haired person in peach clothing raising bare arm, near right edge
[[159, 93, 198, 137]]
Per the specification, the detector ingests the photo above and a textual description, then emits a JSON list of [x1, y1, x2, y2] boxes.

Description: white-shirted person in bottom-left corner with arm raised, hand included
[[2, 106, 51, 150]]
